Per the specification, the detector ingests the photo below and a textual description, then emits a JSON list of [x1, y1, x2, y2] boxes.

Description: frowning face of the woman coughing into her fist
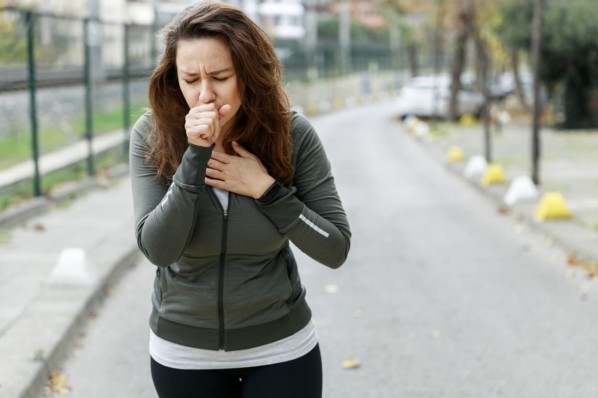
[[176, 38, 241, 126]]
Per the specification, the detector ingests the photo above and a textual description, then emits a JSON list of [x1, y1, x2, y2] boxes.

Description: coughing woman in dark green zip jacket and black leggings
[[130, 1, 351, 398]]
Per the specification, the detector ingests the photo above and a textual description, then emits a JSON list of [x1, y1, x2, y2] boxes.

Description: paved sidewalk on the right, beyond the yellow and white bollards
[[413, 121, 598, 266]]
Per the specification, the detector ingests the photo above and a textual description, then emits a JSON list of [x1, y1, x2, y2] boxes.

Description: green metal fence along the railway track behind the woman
[[0, 8, 400, 202]]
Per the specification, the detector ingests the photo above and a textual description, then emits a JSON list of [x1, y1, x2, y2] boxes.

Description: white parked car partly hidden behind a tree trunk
[[398, 75, 484, 120]]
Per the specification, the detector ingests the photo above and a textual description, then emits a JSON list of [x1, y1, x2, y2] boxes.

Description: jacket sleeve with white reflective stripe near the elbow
[[257, 114, 351, 268]]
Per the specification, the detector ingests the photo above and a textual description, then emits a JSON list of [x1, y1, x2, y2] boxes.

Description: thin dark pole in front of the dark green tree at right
[[532, 0, 544, 185]]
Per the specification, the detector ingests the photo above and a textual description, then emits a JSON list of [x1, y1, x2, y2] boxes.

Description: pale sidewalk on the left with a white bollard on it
[[0, 177, 138, 398]]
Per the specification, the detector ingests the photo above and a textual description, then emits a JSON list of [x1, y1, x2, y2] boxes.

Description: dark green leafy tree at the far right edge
[[503, 0, 598, 128]]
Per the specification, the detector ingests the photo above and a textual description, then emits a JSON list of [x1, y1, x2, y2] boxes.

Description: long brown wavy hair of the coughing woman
[[148, 1, 293, 185]]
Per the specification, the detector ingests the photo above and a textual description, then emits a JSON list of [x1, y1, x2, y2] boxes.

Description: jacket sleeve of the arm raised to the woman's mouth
[[129, 113, 212, 267]]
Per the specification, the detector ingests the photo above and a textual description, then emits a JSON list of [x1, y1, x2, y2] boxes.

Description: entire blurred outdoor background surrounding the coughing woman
[[0, 0, 598, 398]]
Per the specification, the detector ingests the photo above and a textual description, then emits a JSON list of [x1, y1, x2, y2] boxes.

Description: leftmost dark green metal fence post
[[25, 11, 42, 196]]
